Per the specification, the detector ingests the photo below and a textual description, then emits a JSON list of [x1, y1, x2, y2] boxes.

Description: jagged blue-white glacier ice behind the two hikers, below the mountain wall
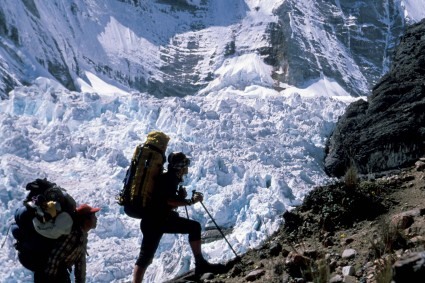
[[0, 71, 352, 282]]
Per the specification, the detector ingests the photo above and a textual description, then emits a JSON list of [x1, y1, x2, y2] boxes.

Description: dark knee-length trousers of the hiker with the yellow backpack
[[136, 211, 201, 268]]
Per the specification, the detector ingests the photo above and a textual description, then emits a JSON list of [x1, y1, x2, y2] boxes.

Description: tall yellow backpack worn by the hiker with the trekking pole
[[117, 131, 170, 219]]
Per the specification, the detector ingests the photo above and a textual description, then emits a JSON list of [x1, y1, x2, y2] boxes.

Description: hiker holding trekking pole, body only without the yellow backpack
[[133, 152, 224, 283]]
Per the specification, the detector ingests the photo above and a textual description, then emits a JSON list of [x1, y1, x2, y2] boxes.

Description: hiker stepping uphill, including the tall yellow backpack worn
[[118, 132, 226, 283]]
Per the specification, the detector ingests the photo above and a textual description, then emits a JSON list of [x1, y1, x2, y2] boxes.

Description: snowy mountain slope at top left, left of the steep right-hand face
[[0, 0, 278, 96]]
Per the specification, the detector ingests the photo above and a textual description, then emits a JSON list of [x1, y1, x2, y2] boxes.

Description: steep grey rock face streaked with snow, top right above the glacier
[[276, 0, 405, 96]]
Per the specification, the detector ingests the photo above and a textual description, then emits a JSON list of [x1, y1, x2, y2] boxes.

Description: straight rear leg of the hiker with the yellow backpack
[[133, 219, 163, 283]]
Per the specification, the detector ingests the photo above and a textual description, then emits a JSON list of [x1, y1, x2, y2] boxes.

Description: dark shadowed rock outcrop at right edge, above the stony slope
[[325, 20, 425, 176]]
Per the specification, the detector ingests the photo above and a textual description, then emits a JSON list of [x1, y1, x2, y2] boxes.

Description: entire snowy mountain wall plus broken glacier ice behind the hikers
[[0, 0, 425, 282]]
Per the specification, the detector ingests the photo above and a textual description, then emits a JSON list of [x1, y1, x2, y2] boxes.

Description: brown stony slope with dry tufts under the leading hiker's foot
[[168, 159, 425, 283]]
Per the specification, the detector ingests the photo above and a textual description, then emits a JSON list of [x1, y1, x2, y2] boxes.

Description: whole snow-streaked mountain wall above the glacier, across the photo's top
[[0, 0, 414, 98]]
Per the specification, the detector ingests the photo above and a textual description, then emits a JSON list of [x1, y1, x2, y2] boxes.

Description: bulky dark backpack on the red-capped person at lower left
[[11, 179, 75, 271]]
